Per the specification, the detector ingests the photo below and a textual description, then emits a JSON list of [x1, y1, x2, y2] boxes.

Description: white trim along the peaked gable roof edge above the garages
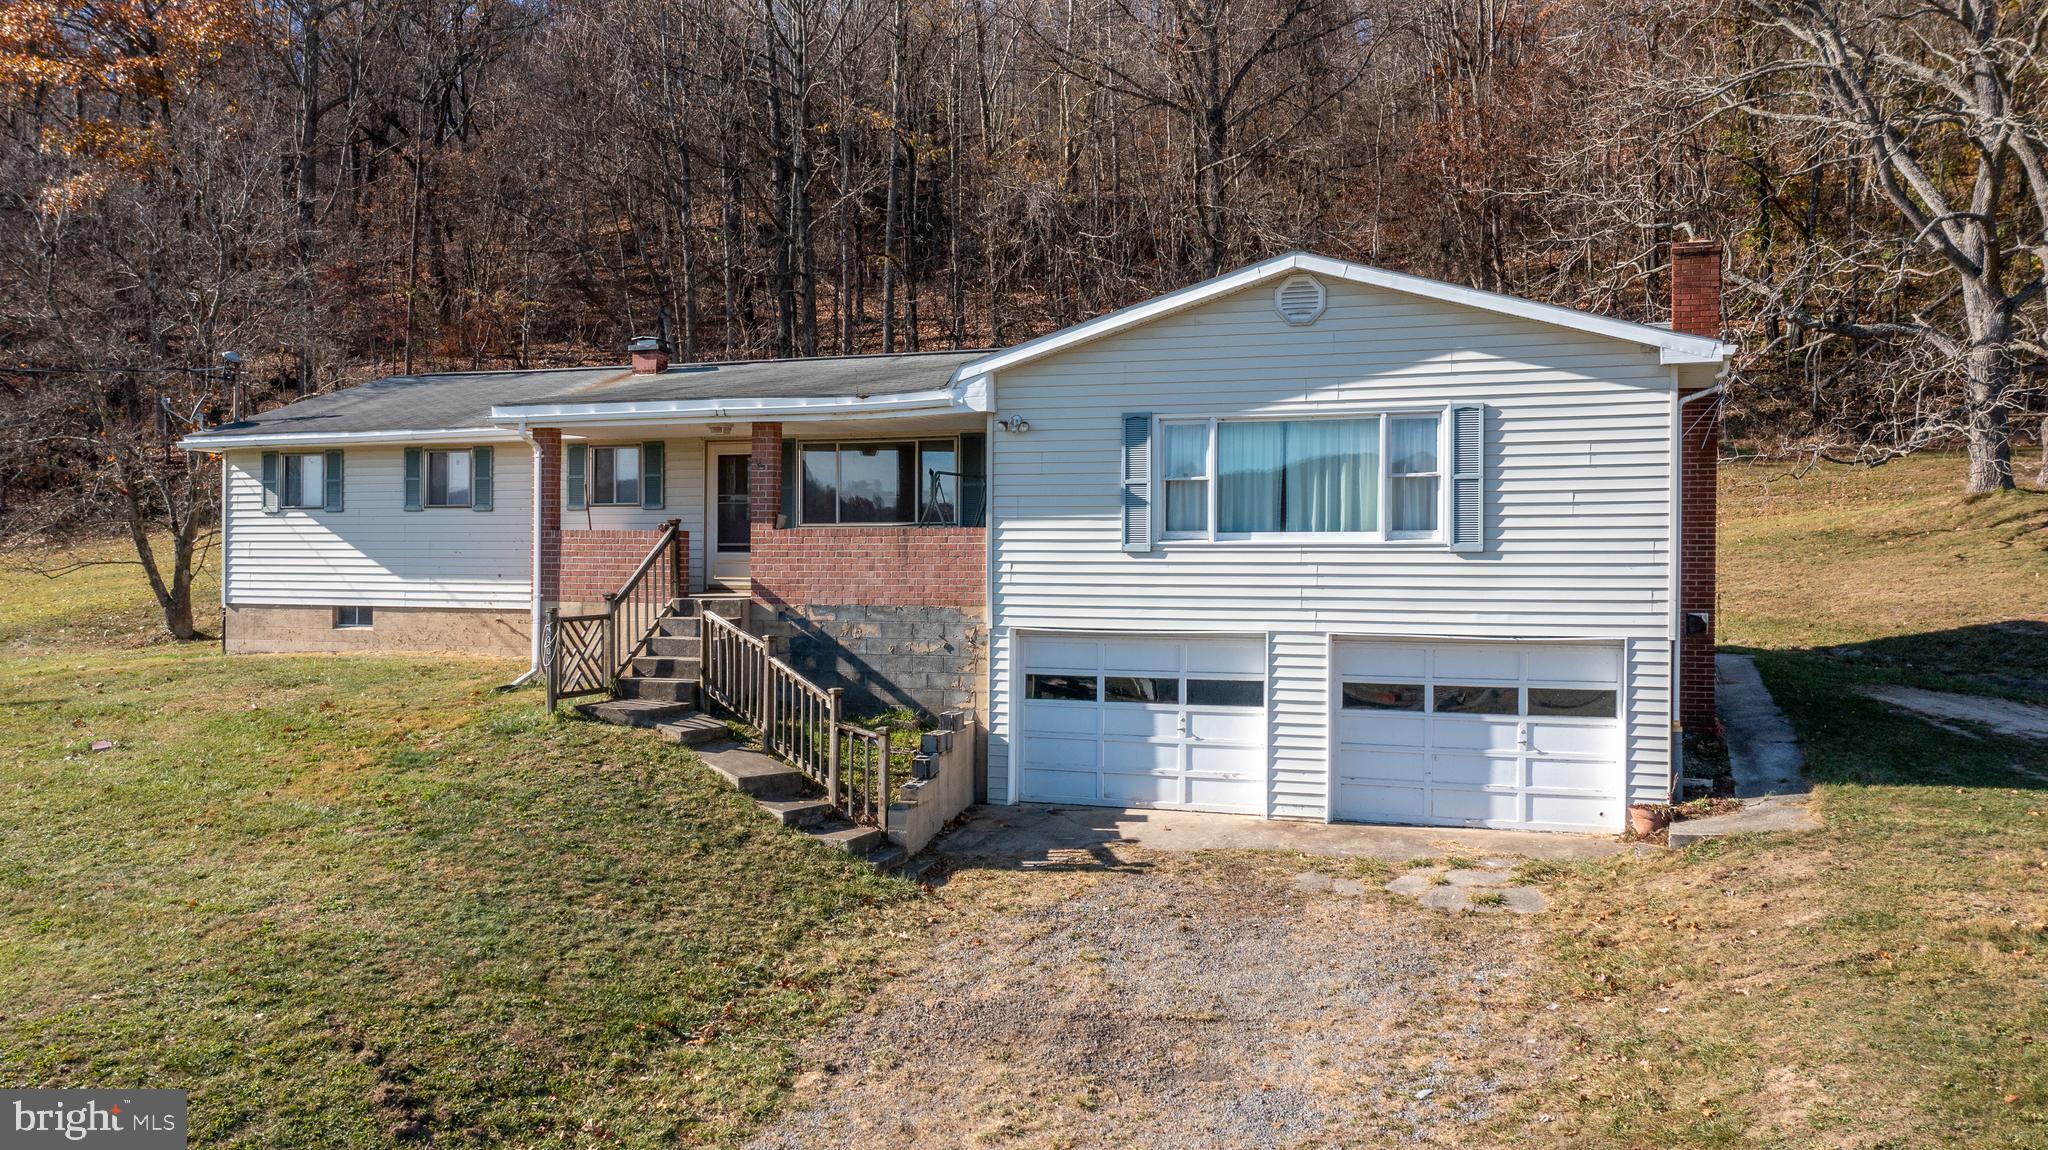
[[961, 252, 1735, 379]]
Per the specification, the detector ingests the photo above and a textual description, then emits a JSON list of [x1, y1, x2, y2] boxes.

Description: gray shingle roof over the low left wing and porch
[[190, 352, 987, 440]]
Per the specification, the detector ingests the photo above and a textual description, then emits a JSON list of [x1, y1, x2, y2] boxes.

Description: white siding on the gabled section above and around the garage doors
[[989, 282, 1673, 819]]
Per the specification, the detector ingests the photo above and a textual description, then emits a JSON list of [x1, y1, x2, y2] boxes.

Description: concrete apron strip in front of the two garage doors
[[934, 802, 1628, 868]]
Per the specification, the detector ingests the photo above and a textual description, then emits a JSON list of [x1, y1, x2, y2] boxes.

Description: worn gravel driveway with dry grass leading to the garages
[[752, 847, 1554, 1150]]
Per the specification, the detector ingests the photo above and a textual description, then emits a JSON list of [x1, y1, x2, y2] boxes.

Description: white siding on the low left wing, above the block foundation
[[225, 444, 532, 610]]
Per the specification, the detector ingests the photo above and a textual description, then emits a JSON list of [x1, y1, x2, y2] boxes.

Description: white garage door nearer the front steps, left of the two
[[1018, 634, 1266, 814]]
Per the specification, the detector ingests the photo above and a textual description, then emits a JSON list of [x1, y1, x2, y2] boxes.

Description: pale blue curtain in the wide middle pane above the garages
[[1217, 419, 1380, 534]]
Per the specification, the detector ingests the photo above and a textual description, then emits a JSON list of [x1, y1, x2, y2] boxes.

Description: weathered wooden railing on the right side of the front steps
[[702, 614, 889, 827]]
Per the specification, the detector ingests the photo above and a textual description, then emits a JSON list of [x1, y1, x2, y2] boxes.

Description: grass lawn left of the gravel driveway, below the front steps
[[0, 548, 915, 1148]]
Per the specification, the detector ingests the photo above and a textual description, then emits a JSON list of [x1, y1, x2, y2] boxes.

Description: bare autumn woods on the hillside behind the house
[[0, 0, 2048, 536]]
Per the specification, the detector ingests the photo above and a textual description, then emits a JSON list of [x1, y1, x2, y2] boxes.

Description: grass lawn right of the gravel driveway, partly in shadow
[[1518, 456, 2048, 1148]]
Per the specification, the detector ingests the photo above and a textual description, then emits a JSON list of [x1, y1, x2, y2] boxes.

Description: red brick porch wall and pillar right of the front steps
[[748, 424, 987, 612]]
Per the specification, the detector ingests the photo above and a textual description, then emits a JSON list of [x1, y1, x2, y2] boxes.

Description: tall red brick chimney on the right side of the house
[[1671, 239, 1720, 731]]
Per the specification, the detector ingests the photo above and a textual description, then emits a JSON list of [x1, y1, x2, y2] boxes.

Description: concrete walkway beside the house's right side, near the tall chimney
[[1669, 655, 1821, 849]]
